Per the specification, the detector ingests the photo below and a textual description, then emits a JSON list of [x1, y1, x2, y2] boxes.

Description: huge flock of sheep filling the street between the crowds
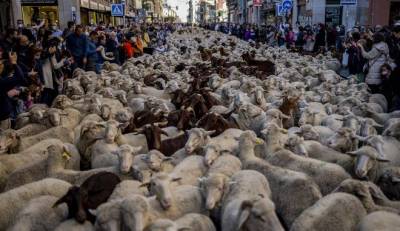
[[0, 29, 400, 231]]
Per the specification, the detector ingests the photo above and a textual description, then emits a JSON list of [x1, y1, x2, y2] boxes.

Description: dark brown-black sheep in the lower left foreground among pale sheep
[[53, 172, 121, 223]]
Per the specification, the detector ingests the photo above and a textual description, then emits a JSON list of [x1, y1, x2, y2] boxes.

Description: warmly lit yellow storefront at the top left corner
[[21, 0, 59, 25]]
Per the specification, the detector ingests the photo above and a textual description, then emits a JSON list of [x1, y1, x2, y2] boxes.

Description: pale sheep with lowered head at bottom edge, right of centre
[[221, 170, 284, 231]]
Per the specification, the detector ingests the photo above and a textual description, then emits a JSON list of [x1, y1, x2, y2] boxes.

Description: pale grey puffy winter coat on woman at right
[[361, 42, 389, 85]]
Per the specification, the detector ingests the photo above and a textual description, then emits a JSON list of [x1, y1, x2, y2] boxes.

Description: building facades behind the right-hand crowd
[[227, 0, 384, 28]]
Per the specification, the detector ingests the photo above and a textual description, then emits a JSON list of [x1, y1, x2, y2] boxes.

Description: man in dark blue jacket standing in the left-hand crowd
[[66, 25, 88, 70]]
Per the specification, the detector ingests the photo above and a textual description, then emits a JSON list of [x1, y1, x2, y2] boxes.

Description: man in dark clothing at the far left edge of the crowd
[[0, 52, 25, 132]]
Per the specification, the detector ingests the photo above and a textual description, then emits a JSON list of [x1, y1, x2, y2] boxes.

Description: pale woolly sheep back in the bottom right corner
[[357, 211, 400, 231]]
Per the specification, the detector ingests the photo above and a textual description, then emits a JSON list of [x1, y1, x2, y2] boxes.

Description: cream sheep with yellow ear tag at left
[[4, 143, 80, 191]]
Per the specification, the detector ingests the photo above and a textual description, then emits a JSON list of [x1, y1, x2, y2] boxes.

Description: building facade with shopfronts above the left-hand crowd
[[9, 0, 142, 28]]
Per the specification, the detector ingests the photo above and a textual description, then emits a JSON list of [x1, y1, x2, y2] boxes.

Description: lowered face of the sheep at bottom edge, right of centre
[[237, 195, 284, 231]]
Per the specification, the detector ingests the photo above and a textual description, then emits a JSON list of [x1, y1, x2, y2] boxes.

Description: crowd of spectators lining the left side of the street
[[0, 20, 175, 131]]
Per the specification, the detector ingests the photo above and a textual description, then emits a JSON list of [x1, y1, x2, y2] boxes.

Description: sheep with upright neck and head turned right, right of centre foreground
[[239, 131, 322, 227]]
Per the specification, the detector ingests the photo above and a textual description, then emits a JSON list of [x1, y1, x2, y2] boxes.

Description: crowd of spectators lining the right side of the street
[[202, 23, 400, 111]]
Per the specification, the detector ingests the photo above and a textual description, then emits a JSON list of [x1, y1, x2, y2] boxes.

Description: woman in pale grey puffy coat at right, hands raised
[[357, 32, 389, 94]]
